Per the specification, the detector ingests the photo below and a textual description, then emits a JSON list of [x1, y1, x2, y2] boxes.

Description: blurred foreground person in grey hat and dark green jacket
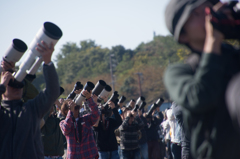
[[164, 0, 240, 159]]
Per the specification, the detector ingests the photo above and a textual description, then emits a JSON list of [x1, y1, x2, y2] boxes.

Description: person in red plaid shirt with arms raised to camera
[[60, 90, 99, 159]]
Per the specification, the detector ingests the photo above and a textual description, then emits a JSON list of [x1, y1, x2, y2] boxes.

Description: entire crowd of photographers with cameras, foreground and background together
[[0, 0, 240, 159]]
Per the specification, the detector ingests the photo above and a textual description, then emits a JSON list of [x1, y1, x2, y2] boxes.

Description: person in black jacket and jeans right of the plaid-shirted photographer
[[93, 101, 122, 159]]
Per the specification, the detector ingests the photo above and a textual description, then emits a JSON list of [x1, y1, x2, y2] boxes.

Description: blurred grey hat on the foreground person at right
[[165, 0, 219, 41]]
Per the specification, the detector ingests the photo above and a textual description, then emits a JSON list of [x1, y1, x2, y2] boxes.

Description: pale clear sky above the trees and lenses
[[0, 0, 170, 64]]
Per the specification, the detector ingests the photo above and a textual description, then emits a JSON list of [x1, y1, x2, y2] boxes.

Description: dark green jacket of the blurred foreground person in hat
[[164, 45, 240, 159]]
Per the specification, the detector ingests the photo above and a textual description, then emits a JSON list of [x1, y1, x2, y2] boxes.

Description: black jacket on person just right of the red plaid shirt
[[93, 108, 122, 151]]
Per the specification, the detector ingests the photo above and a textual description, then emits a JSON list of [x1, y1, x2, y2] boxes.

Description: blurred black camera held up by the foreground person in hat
[[210, 1, 240, 40]]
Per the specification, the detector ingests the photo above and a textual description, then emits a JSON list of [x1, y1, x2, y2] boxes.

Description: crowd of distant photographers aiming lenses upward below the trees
[[41, 80, 181, 159]]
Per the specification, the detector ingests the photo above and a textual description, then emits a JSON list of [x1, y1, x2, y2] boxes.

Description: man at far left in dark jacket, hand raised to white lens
[[0, 41, 60, 158]]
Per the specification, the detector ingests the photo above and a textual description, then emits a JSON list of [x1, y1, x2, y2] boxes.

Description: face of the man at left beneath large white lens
[[2, 86, 23, 100]]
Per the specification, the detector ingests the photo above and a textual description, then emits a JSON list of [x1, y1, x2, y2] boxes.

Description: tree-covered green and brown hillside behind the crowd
[[33, 36, 190, 102]]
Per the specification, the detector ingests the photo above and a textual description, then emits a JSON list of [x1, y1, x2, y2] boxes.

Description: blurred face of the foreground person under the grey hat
[[179, 2, 212, 46]]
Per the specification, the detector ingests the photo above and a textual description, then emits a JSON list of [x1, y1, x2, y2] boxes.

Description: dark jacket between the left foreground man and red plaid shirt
[[41, 113, 64, 156]]
